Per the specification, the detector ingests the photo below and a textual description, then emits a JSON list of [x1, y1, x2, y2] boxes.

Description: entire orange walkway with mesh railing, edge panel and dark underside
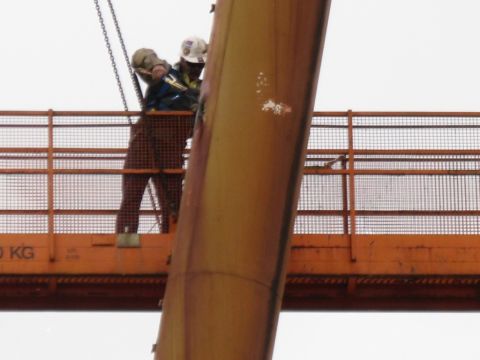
[[0, 111, 480, 310]]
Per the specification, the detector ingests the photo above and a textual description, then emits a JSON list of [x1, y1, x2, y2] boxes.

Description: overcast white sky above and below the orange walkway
[[0, 0, 480, 360]]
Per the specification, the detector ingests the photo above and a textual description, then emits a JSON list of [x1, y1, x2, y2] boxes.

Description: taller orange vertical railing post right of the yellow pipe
[[348, 110, 357, 261]]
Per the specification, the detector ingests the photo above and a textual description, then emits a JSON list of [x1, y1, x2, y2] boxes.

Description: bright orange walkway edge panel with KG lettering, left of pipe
[[0, 234, 173, 276]]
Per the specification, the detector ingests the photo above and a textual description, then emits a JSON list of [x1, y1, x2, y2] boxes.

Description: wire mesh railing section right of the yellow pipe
[[295, 112, 480, 234]]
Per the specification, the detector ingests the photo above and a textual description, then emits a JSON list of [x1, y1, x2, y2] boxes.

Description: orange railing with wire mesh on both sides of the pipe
[[0, 110, 480, 239]]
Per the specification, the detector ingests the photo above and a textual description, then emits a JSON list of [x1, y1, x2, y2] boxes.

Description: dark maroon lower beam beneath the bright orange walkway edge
[[4, 274, 480, 311]]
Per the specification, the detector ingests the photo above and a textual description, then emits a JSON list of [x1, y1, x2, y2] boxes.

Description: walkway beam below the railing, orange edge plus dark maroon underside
[[0, 234, 480, 310]]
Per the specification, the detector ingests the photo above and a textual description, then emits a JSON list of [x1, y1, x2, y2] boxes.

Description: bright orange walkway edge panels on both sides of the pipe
[[0, 234, 480, 277]]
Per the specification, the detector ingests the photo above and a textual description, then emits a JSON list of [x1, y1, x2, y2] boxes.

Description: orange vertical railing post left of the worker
[[47, 109, 55, 261]]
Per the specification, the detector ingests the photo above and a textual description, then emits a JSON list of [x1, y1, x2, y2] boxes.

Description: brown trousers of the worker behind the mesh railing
[[116, 116, 194, 233]]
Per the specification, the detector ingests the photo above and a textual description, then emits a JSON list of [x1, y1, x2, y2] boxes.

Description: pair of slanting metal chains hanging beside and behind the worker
[[93, 0, 161, 229]]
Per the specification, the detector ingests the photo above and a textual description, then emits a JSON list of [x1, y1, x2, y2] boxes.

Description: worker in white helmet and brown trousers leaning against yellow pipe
[[116, 37, 208, 233]]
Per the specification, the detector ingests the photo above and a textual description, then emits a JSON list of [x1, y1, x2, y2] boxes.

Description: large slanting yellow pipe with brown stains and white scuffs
[[155, 0, 330, 360]]
